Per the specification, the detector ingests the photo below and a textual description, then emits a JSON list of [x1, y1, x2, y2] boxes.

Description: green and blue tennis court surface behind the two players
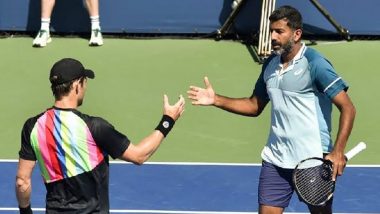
[[0, 37, 380, 214]]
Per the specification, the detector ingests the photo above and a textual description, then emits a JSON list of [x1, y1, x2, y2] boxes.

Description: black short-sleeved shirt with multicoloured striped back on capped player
[[19, 107, 130, 213]]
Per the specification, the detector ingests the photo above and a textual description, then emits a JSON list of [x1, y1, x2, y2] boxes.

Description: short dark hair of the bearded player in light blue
[[269, 5, 302, 30]]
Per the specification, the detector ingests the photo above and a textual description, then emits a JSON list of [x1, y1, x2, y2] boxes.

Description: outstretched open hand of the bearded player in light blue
[[187, 77, 215, 106]]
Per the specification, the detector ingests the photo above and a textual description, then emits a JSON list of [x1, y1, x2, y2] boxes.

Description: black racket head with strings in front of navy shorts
[[295, 164, 334, 205]]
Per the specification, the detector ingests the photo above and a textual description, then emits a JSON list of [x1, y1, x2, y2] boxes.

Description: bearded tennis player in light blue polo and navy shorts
[[188, 6, 356, 214]]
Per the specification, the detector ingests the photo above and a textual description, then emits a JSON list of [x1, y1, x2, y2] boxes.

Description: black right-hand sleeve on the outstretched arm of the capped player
[[88, 117, 130, 159]]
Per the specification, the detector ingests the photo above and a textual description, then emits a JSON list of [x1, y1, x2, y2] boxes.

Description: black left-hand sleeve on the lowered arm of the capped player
[[18, 118, 37, 161]]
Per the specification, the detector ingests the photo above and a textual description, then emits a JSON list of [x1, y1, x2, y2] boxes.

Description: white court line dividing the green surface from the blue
[[0, 159, 380, 168]]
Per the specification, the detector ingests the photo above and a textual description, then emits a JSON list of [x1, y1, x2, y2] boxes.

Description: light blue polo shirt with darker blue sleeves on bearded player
[[253, 44, 348, 168]]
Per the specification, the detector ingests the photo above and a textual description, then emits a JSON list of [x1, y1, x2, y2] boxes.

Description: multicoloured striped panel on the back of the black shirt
[[31, 109, 104, 183]]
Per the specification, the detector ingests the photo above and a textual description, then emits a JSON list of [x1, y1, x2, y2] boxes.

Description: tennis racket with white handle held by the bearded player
[[293, 142, 366, 206]]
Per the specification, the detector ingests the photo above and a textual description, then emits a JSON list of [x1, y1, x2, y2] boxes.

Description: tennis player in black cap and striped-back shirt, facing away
[[16, 58, 185, 214]]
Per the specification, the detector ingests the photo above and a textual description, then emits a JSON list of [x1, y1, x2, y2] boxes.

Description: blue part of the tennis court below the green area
[[0, 161, 380, 214]]
